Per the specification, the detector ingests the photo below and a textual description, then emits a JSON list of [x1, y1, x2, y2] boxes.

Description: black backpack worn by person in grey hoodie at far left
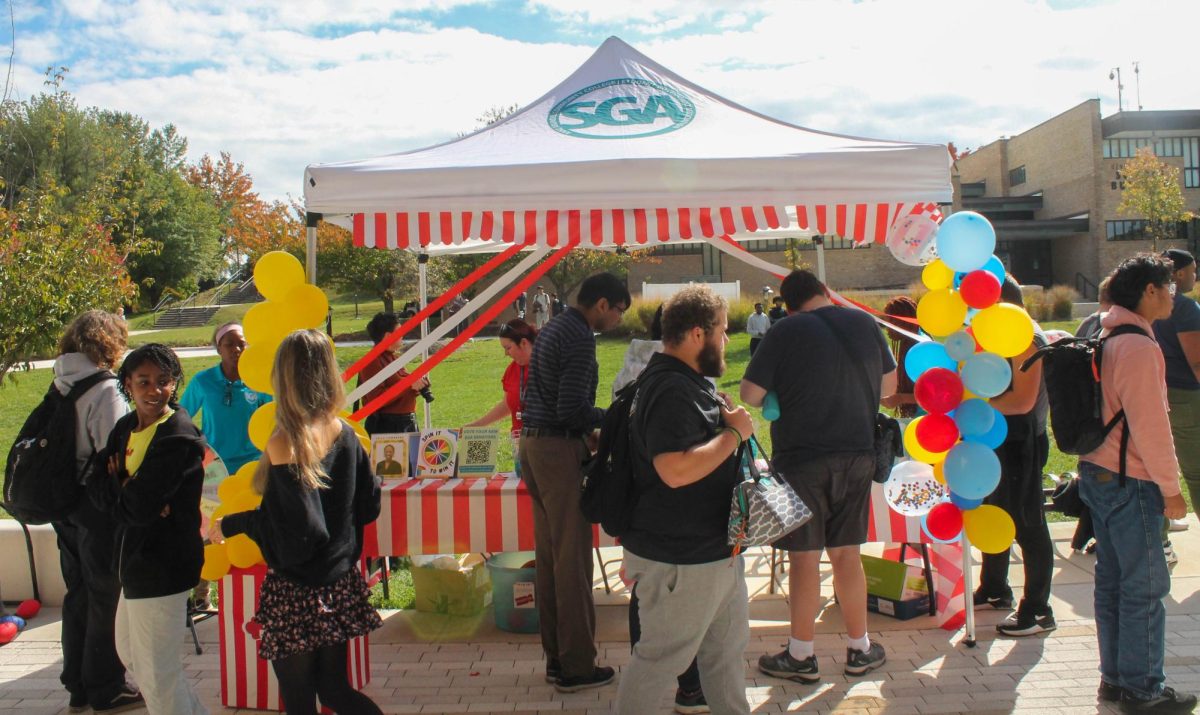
[[0, 371, 116, 524]]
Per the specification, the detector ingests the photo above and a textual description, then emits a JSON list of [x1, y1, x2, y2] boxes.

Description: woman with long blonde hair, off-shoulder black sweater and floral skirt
[[209, 330, 383, 715]]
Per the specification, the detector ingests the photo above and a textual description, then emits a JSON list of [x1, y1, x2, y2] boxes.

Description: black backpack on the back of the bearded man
[[580, 366, 660, 537]]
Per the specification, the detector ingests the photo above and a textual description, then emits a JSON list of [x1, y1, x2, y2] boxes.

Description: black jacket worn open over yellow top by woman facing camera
[[88, 408, 205, 599]]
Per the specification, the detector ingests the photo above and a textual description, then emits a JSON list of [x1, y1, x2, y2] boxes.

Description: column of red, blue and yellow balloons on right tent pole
[[884, 211, 1033, 553]]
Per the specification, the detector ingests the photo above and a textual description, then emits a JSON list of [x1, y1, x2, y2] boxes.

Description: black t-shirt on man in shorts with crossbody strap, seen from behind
[[745, 306, 896, 469]]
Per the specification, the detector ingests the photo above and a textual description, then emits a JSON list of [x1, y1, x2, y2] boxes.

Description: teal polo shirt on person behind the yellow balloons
[[179, 363, 271, 474]]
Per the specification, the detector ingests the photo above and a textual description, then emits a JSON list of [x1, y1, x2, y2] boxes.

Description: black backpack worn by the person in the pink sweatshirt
[[1021, 325, 1148, 480]]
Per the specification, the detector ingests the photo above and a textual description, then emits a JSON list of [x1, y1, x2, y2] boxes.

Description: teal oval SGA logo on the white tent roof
[[546, 77, 696, 139]]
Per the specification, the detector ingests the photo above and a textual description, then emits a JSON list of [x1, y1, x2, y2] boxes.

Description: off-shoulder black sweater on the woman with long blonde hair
[[221, 422, 379, 587]]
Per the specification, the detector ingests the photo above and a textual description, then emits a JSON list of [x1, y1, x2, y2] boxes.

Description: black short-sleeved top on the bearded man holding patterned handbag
[[620, 353, 737, 564]]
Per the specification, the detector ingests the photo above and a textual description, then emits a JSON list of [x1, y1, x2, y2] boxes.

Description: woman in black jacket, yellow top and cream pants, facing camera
[[88, 343, 208, 715]]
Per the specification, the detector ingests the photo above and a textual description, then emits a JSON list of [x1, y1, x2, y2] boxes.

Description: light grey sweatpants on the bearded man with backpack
[[616, 551, 750, 715]]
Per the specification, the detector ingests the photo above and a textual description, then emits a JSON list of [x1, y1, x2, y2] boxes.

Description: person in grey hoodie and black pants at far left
[[52, 311, 142, 713]]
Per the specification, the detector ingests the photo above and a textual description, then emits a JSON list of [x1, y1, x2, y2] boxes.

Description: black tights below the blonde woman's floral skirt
[[271, 643, 383, 715]]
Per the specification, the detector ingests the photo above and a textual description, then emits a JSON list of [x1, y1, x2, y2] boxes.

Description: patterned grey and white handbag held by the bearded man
[[728, 435, 812, 555]]
